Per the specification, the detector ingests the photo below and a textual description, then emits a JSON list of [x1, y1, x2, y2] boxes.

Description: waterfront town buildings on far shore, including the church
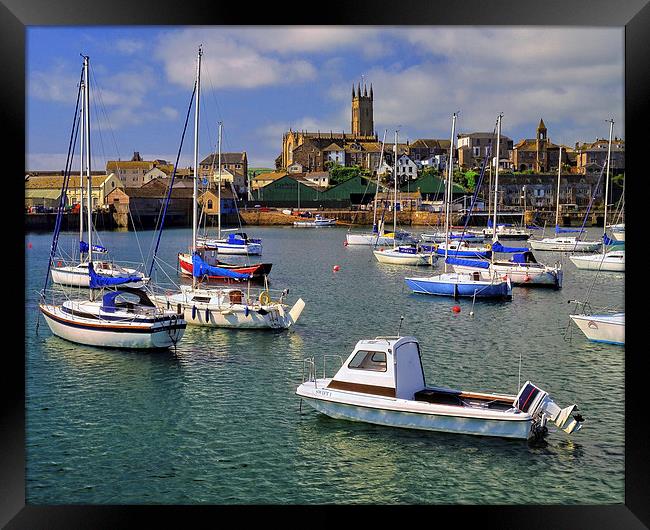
[[25, 83, 625, 227]]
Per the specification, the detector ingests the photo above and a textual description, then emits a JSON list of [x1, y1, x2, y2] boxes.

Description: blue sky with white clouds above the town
[[26, 26, 625, 170]]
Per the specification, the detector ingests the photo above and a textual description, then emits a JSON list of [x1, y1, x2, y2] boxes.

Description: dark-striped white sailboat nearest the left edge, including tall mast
[[39, 56, 187, 349]]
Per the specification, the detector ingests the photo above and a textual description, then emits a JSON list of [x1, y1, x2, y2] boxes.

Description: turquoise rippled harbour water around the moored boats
[[25, 227, 625, 504]]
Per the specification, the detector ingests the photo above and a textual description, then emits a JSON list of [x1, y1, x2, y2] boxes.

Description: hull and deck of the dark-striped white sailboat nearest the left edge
[[39, 288, 187, 349]]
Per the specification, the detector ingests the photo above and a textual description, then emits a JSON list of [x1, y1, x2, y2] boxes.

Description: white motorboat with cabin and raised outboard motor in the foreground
[[296, 337, 584, 440]]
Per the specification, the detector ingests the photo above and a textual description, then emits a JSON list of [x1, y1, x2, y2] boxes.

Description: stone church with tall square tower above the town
[[276, 83, 408, 172]]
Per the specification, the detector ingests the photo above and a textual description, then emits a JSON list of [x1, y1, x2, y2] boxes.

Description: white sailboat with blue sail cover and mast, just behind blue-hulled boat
[[450, 114, 563, 289]]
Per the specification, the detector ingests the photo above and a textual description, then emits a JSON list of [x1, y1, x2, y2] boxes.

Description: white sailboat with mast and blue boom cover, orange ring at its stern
[[152, 48, 305, 329]]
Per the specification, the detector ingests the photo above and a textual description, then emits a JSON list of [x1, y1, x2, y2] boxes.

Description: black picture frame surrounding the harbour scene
[[0, 0, 650, 529]]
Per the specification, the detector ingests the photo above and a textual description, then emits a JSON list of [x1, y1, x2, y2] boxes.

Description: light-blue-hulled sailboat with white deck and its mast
[[404, 113, 512, 300]]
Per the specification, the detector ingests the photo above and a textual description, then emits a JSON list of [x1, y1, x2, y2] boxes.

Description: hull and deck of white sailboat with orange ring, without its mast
[[151, 285, 305, 329]]
